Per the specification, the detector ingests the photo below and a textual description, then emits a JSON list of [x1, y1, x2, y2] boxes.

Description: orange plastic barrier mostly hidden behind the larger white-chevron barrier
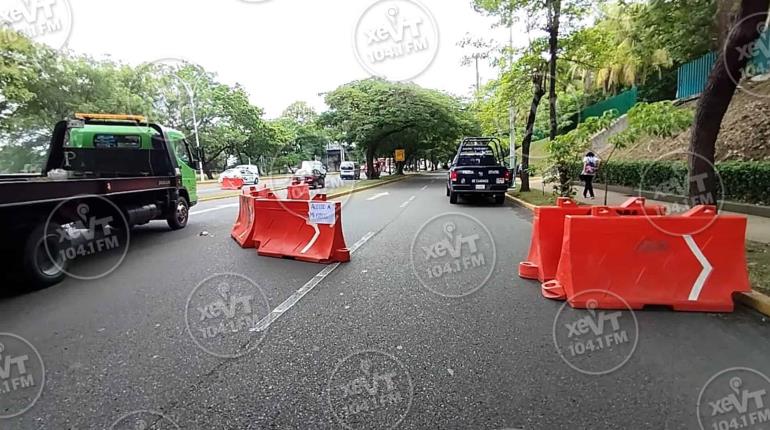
[[519, 197, 666, 282]]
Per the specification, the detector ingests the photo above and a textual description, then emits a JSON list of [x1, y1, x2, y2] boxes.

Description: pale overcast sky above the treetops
[[9, 0, 526, 118]]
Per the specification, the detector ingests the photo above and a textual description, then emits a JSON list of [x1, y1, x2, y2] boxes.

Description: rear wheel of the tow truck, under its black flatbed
[[22, 222, 69, 288]]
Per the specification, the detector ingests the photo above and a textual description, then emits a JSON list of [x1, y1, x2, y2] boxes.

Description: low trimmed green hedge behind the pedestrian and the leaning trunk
[[572, 161, 770, 205]]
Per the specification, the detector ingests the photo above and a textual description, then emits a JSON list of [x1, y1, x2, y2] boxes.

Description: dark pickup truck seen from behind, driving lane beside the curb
[[446, 137, 512, 204]]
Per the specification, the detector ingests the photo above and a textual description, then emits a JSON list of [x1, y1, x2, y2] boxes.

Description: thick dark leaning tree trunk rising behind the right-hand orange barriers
[[688, 0, 770, 205]]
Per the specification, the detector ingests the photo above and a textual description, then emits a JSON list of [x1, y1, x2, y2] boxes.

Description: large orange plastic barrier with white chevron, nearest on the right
[[543, 206, 751, 312]]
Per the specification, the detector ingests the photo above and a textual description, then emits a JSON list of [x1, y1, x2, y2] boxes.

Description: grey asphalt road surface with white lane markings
[[0, 175, 770, 429]]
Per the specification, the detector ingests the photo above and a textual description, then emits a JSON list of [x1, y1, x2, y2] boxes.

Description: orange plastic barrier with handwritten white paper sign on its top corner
[[252, 195, 350, 263]]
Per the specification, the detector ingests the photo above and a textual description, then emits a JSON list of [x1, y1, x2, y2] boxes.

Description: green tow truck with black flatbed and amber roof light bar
[[0, 114, 198, 288]]
